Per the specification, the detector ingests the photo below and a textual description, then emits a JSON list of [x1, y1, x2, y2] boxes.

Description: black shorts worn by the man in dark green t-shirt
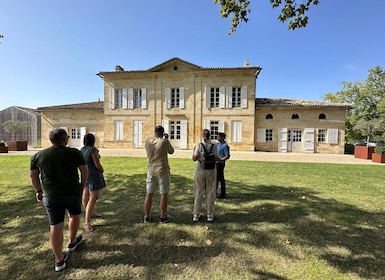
[[43, 195, 82, 225]]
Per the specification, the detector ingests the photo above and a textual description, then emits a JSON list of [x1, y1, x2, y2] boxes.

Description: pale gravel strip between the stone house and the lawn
[[7, 148, 380, 165]]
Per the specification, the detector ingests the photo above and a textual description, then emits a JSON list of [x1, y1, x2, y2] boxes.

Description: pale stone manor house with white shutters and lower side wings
[[33, 58, 350, 153]]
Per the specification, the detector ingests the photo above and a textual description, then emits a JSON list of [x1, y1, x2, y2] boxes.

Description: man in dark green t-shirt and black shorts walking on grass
[[30, 128, 88, 271]]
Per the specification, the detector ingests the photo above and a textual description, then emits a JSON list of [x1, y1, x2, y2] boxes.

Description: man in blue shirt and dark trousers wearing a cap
[[217, 132, 230, 199]]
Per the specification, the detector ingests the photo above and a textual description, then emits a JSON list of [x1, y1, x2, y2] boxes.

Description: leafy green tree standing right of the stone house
[[323, 66, 385, 141]]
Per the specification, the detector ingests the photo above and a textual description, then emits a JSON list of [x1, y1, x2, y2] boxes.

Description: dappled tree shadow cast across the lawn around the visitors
[[0, 173, 385, 279]]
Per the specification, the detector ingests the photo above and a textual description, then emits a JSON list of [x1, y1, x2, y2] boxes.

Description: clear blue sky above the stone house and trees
[[0, 0, 385, 110]]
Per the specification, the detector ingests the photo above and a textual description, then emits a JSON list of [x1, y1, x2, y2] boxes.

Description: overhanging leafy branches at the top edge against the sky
[[214, 0, 319, 34]]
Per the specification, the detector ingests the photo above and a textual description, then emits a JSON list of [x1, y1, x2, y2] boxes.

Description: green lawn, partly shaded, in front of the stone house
[[0, 156, 385, 280]]
